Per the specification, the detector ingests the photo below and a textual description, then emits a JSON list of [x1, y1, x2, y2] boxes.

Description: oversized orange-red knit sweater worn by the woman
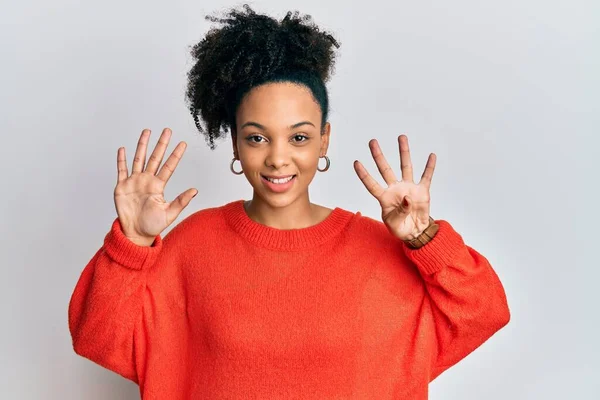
[[69, 200, 510, 400]]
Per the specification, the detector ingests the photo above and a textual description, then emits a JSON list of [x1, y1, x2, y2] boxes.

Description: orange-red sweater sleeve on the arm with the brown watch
[[403, 220, 510, 381]]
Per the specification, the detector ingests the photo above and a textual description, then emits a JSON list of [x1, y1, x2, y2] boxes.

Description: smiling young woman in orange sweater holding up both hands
[[69, 6, 510, 400]]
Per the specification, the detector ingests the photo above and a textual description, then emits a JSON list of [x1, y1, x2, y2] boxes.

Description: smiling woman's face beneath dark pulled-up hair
[[233, 82, 330, 207]]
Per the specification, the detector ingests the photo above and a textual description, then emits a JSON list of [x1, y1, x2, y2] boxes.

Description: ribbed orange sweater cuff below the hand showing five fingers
[[104, 217, 162, 270]]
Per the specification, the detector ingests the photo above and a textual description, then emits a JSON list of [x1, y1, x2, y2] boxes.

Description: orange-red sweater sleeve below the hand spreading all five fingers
[[68, 218, 162, 383]]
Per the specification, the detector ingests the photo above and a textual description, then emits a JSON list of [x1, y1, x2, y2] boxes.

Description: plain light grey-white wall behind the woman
[[0, 0, 600, 400]]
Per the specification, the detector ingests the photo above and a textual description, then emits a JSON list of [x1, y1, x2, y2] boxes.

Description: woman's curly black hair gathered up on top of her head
[[186, 4, 340, 150]]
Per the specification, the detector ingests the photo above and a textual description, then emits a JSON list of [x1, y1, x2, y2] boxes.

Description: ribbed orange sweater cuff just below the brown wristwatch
[[403, 220, 465, 275]]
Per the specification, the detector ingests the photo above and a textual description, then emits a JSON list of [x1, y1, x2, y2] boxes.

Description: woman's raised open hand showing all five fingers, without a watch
[[114, 128, 198, 246]]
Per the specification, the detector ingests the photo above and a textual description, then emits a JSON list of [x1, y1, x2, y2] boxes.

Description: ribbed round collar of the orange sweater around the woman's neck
[[221, 199, 357, 250]]
